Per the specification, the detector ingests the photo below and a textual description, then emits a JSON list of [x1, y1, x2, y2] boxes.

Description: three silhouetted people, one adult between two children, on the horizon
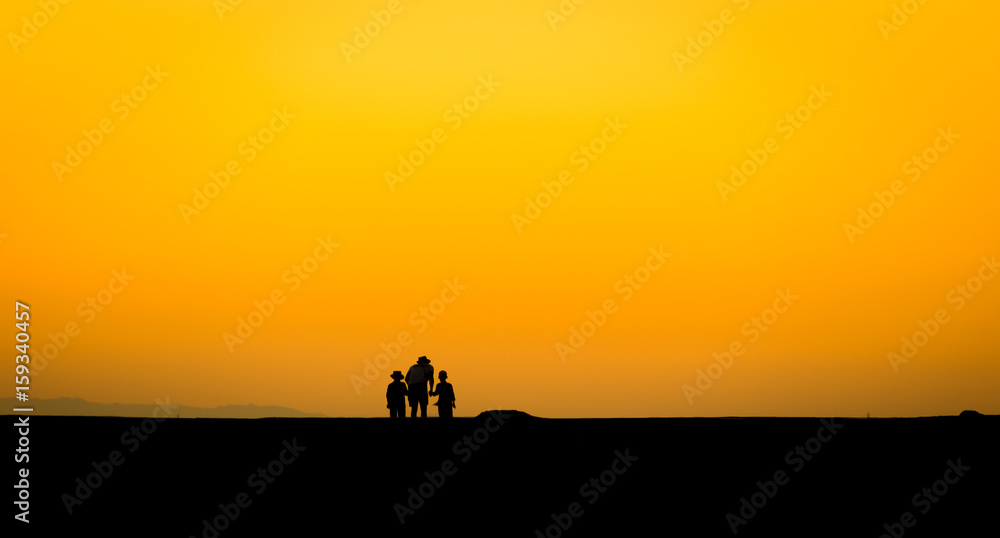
[[385, 357, 455, 418]]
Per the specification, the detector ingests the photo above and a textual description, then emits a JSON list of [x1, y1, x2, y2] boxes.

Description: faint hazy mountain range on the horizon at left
[[0, 398, 326, 418]]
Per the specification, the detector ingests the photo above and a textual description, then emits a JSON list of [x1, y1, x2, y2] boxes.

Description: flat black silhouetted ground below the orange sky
[[7, 412, 1000, 538]]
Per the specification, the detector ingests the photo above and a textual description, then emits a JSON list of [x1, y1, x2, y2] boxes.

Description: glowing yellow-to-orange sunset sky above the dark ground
[[0, 0, 1000, 417]]
